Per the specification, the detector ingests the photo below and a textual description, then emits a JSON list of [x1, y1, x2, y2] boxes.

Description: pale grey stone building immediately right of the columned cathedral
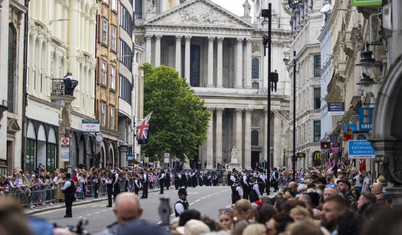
[[286, 1, 324, 169]]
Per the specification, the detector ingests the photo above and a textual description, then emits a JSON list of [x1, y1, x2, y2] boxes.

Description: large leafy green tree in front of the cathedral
[[141, 63, 211, 161]]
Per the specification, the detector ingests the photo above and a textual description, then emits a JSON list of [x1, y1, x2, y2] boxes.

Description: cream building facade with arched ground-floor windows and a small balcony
[[24, 0, 97, 171]]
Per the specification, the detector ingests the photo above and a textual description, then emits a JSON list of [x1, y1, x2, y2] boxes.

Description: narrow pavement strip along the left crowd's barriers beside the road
[[24, 188, 159, 215]]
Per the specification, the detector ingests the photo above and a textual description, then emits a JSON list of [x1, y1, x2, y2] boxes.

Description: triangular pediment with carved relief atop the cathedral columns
[[144, 0, 253, 30]]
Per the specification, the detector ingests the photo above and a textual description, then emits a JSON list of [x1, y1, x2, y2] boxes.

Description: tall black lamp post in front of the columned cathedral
[[261, 3, 278, 195]]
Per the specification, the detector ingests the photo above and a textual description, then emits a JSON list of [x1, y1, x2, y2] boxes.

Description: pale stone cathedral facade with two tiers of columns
[[135, 0, 290, 169]]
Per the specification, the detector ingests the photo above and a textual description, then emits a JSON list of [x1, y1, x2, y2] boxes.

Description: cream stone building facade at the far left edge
[[0, 0, 27, 175]]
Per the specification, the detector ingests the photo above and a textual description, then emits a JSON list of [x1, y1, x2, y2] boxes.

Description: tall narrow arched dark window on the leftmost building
[[7, 24, 16, 113]]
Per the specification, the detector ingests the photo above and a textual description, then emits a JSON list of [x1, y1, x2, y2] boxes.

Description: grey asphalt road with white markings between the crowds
[[34, 186, 231, 234]]
